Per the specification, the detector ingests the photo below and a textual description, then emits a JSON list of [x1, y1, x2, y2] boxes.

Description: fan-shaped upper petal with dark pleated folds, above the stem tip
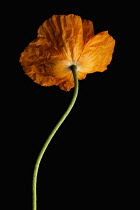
[[38, 14, 83, 61]]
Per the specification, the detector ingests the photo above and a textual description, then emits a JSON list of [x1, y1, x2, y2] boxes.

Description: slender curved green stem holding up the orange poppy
[[32, 65, 79, 210]]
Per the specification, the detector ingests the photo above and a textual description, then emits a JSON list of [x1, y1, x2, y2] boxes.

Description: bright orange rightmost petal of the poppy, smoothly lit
[[78, 31, 115, 73]]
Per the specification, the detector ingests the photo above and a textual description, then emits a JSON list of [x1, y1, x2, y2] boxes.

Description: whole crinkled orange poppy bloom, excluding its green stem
[[20, 14, 115, 91]]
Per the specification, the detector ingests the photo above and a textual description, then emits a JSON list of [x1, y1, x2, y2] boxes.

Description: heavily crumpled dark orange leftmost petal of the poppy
[[20, 38, 72, 86]]
